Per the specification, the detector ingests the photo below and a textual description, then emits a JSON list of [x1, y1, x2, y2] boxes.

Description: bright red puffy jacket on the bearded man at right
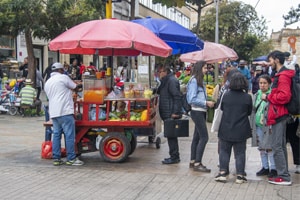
[[267, 67, 295, 125]]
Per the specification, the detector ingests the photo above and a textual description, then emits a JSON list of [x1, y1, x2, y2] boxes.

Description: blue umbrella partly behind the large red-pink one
[[132, 17, 204, 55]]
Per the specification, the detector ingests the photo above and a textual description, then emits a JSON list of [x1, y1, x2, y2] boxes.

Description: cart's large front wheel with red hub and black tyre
[[99, 132, 131, 163]]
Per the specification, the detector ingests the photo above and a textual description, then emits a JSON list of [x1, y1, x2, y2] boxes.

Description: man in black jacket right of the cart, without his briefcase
[[157, 66, 182, 164]]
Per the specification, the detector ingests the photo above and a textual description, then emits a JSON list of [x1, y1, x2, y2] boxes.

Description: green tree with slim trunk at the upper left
[[0, 0, 105, 84]]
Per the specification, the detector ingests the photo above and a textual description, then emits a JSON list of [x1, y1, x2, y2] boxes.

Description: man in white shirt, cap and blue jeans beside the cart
[[45, 63, 84, 166]]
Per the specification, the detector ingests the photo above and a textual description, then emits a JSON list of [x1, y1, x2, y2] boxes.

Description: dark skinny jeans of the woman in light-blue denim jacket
[[191, 110, 208, 163]]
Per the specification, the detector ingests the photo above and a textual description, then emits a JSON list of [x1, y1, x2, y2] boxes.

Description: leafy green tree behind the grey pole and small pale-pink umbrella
[[200, 2, 271, 60]]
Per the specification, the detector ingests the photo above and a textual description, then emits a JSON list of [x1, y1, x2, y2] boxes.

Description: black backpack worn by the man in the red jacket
[[286, 70, 300, 115]]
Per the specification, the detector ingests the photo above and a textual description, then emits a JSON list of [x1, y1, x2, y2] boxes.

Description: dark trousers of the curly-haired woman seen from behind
[[219, 139, 247, 176]]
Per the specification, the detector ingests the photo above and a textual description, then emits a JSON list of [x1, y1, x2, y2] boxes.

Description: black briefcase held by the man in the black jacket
[[164, 119, 189, 138]]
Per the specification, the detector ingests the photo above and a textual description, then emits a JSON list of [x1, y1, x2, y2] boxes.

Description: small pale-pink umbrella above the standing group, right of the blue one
[[179, 42, 238, 63]]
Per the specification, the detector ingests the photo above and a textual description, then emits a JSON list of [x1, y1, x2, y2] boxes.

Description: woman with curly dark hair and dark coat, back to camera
[[215, 73, 252, 183]]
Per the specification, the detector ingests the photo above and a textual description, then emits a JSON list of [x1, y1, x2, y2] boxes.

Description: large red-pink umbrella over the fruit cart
[[49, 19, 172, 57]]
